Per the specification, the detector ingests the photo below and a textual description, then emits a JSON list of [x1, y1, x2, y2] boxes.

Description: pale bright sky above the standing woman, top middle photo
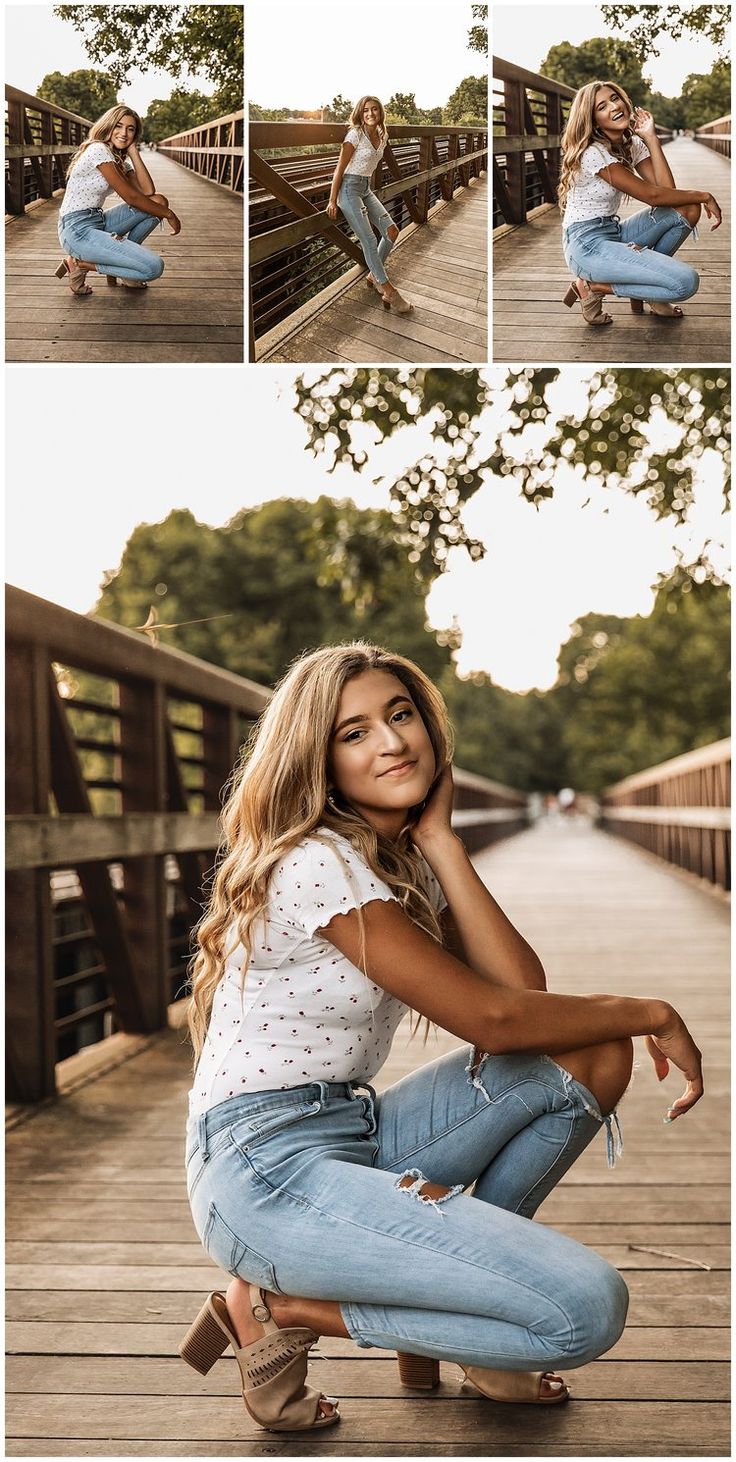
[[246, 0, 487, 111]]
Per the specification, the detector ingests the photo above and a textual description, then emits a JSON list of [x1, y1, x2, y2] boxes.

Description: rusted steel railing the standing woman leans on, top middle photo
[[249, 121, 489, 344]]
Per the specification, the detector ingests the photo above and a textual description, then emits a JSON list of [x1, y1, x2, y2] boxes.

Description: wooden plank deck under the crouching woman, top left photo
[[6, 154, 244, 364]]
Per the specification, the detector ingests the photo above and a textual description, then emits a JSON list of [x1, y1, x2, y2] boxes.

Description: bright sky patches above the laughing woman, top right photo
[[493, 0, 728, 96]]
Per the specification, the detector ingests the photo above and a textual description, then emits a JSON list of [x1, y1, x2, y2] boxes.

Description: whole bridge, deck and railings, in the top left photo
[[6, 86, 244, 363]]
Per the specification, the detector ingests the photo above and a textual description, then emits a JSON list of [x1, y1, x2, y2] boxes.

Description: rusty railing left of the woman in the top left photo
[[4, 86, 92, 215]]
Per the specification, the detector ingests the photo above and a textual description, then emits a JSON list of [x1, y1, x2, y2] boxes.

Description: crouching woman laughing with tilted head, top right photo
[[559, 82, 721, 326]]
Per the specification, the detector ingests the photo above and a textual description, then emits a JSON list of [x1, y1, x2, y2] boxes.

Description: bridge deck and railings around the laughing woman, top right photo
[[493, 58, 730, 364]]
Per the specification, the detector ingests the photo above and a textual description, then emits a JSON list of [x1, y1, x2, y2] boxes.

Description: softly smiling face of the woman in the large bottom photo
[[329, 670, 436, 836]]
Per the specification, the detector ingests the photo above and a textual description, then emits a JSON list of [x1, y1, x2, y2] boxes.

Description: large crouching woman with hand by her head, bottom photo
[[180, 643, 702, 1430]]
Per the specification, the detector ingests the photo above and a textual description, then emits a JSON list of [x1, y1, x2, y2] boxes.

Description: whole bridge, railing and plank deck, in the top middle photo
[[249, 123, 487, 364]]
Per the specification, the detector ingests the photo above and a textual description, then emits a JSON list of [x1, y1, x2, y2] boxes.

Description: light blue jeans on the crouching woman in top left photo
[[59, 203, 164, 281]]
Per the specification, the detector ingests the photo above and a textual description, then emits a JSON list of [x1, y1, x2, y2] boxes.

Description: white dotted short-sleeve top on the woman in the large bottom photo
[[189, 827, 445, 1116]]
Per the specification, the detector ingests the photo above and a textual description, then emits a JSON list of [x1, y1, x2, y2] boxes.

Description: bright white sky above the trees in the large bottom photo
[[6, 366, 727, 690]]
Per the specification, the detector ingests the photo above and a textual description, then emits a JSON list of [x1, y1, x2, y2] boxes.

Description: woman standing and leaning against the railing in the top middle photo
[[326, 96, 413, 314]]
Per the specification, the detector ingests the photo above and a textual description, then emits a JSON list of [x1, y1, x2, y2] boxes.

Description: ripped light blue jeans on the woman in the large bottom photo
[[186, 1048, 628, 1370]]
